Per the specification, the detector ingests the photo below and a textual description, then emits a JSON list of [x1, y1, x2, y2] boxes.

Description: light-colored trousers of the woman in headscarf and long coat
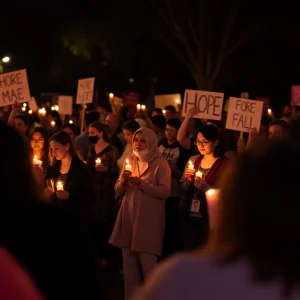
[[122, 248, 157, 300]]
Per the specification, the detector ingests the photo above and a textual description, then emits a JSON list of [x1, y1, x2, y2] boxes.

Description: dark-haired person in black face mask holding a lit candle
[[87, 121, 119, 266]]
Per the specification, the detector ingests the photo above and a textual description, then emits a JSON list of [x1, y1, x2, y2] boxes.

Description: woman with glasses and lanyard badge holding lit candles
[[180, 125, 227, 250]]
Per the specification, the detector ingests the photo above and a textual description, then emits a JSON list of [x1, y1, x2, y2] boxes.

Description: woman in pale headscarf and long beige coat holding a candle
[[110, 127, 171, 300]]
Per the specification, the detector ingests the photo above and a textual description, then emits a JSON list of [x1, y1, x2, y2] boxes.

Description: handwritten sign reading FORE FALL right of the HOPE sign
[[226, 97, 264, 132]]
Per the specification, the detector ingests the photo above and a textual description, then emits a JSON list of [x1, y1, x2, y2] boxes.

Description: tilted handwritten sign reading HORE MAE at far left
[[0, 69, 30, 106]]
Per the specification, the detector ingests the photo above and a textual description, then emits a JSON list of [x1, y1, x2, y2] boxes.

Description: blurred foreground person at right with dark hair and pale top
[[133, 140, 300, 300]]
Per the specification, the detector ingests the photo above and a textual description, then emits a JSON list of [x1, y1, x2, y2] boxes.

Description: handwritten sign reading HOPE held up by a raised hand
[[182, 90, 224, 120]]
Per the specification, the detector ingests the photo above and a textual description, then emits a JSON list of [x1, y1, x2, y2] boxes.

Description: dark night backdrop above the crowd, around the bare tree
[[0, 0, 300, 110]]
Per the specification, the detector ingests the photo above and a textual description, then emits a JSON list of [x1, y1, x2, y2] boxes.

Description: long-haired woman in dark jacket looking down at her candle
[[45, 131, 93, 222]]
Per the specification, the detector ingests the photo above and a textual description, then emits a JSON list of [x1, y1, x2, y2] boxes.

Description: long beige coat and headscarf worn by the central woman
[[109, 128, 171, 256]]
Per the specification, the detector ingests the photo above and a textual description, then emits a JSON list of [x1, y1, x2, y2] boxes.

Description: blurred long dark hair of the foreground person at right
[[208, 140, 300, 298]]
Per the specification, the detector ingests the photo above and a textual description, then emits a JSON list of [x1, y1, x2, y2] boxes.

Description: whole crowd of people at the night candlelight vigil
[[0, 99, 300, 300]]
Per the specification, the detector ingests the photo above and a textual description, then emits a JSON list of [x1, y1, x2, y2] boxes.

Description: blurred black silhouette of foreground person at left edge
[[0, 123, 101, 300]]
